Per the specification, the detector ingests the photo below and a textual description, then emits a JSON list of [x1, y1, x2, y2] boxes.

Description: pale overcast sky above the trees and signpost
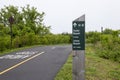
[[0, 0, 120, 33]]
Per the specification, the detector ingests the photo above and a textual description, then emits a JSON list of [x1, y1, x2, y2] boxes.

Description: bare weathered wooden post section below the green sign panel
[[73, 50, 85, 80]]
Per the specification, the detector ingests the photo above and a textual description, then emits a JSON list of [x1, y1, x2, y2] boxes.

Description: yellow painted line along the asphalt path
[[0, 52, 45, 75]]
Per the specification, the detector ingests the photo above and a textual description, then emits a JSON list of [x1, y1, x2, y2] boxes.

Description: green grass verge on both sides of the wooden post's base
[[55, 46, 120, 80]]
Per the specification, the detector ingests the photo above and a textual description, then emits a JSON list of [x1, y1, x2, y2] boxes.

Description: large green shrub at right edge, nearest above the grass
[[96, 35, 120, 62]]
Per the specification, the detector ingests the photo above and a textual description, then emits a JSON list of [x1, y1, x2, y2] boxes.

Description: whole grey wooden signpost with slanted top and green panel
[[72, 15, 85, 80]]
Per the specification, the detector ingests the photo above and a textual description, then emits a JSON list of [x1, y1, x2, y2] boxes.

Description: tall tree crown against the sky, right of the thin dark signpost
[[22, 5, 45, 34]]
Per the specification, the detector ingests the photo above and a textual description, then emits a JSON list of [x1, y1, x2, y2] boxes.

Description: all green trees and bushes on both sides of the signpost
[[0, 5, 120, 62]]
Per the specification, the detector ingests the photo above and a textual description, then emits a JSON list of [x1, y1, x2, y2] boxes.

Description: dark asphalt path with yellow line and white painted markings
[[0, 45, 72, 80]]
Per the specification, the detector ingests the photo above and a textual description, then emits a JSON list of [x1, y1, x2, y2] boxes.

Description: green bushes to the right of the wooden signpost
[[86, 29, 120, 62]]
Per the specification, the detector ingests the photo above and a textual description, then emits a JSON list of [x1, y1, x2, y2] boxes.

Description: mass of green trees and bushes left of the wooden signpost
[[0, 5, 71, 52]]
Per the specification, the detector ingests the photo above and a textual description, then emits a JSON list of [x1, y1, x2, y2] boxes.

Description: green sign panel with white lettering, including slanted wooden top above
[[72, 15, 85, 50]]
